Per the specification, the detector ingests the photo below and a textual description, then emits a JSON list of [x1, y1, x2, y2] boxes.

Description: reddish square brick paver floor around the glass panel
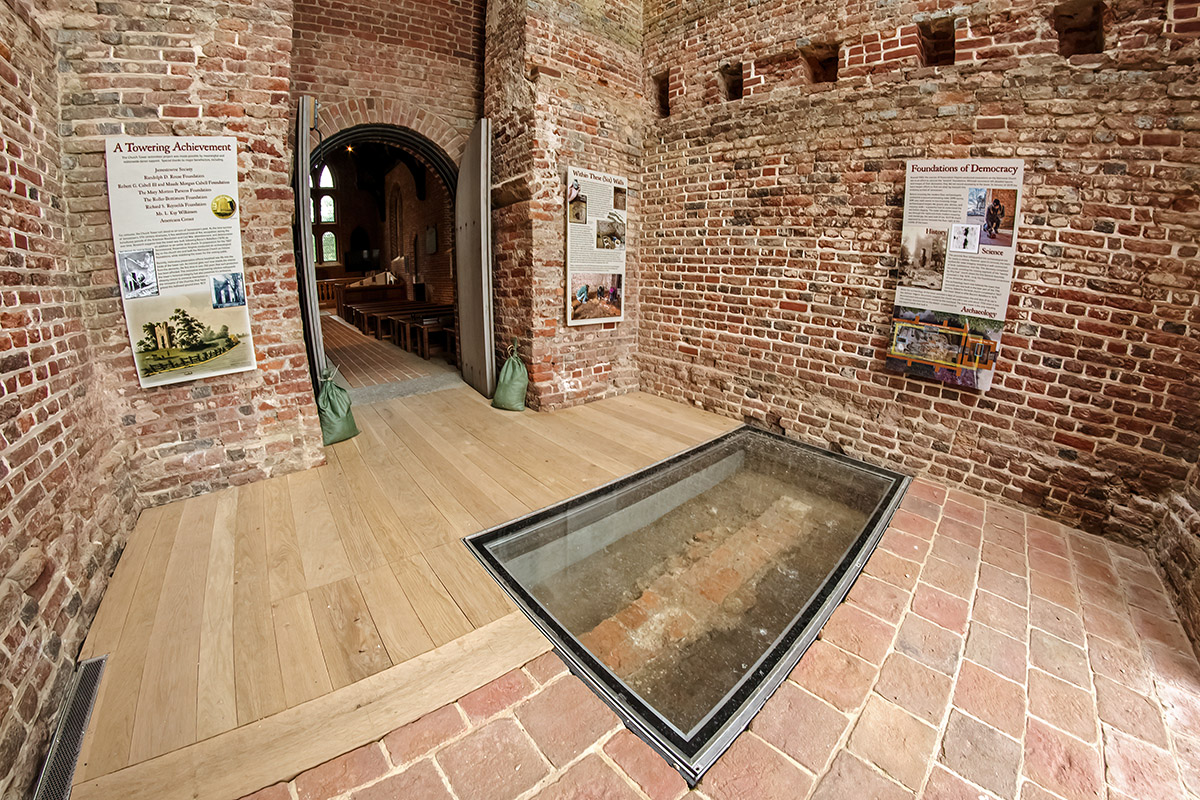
[[236, 481, 1200, 800]]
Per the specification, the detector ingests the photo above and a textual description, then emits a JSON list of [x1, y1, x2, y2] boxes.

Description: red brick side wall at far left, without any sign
[[0, 0, 134, 798]]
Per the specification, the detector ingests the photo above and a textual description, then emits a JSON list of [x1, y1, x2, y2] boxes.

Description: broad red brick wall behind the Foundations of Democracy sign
[[638, 0, 1200, 541]]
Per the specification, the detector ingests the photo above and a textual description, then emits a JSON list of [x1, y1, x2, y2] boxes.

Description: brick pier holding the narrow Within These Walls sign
[[487, 1, 646, 408]]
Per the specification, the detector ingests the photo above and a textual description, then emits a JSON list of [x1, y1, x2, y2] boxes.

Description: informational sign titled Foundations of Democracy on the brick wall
[[887, 158, 1025, 391]]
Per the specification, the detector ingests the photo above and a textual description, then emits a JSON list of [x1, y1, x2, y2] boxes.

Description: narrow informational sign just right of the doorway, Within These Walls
[[566, 167, 629, 325]]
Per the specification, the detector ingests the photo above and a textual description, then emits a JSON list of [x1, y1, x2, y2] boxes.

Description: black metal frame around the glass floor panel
[[463, 426, 911, 786]]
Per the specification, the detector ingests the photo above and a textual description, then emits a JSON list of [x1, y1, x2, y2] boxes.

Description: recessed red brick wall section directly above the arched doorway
[[292, 0, 484, 162]]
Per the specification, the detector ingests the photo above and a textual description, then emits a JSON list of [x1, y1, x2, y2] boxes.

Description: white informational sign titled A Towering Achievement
[[104, 137, 256, 387]]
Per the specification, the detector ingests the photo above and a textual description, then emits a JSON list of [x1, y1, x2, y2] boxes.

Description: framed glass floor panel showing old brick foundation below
[[466, 427, 908, 783]]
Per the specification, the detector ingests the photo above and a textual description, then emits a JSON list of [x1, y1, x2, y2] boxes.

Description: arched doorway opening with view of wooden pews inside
[[301, 125, 458, 402]]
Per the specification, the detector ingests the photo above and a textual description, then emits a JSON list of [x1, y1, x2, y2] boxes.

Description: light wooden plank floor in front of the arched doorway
[[76, 386, 737, 796]]
